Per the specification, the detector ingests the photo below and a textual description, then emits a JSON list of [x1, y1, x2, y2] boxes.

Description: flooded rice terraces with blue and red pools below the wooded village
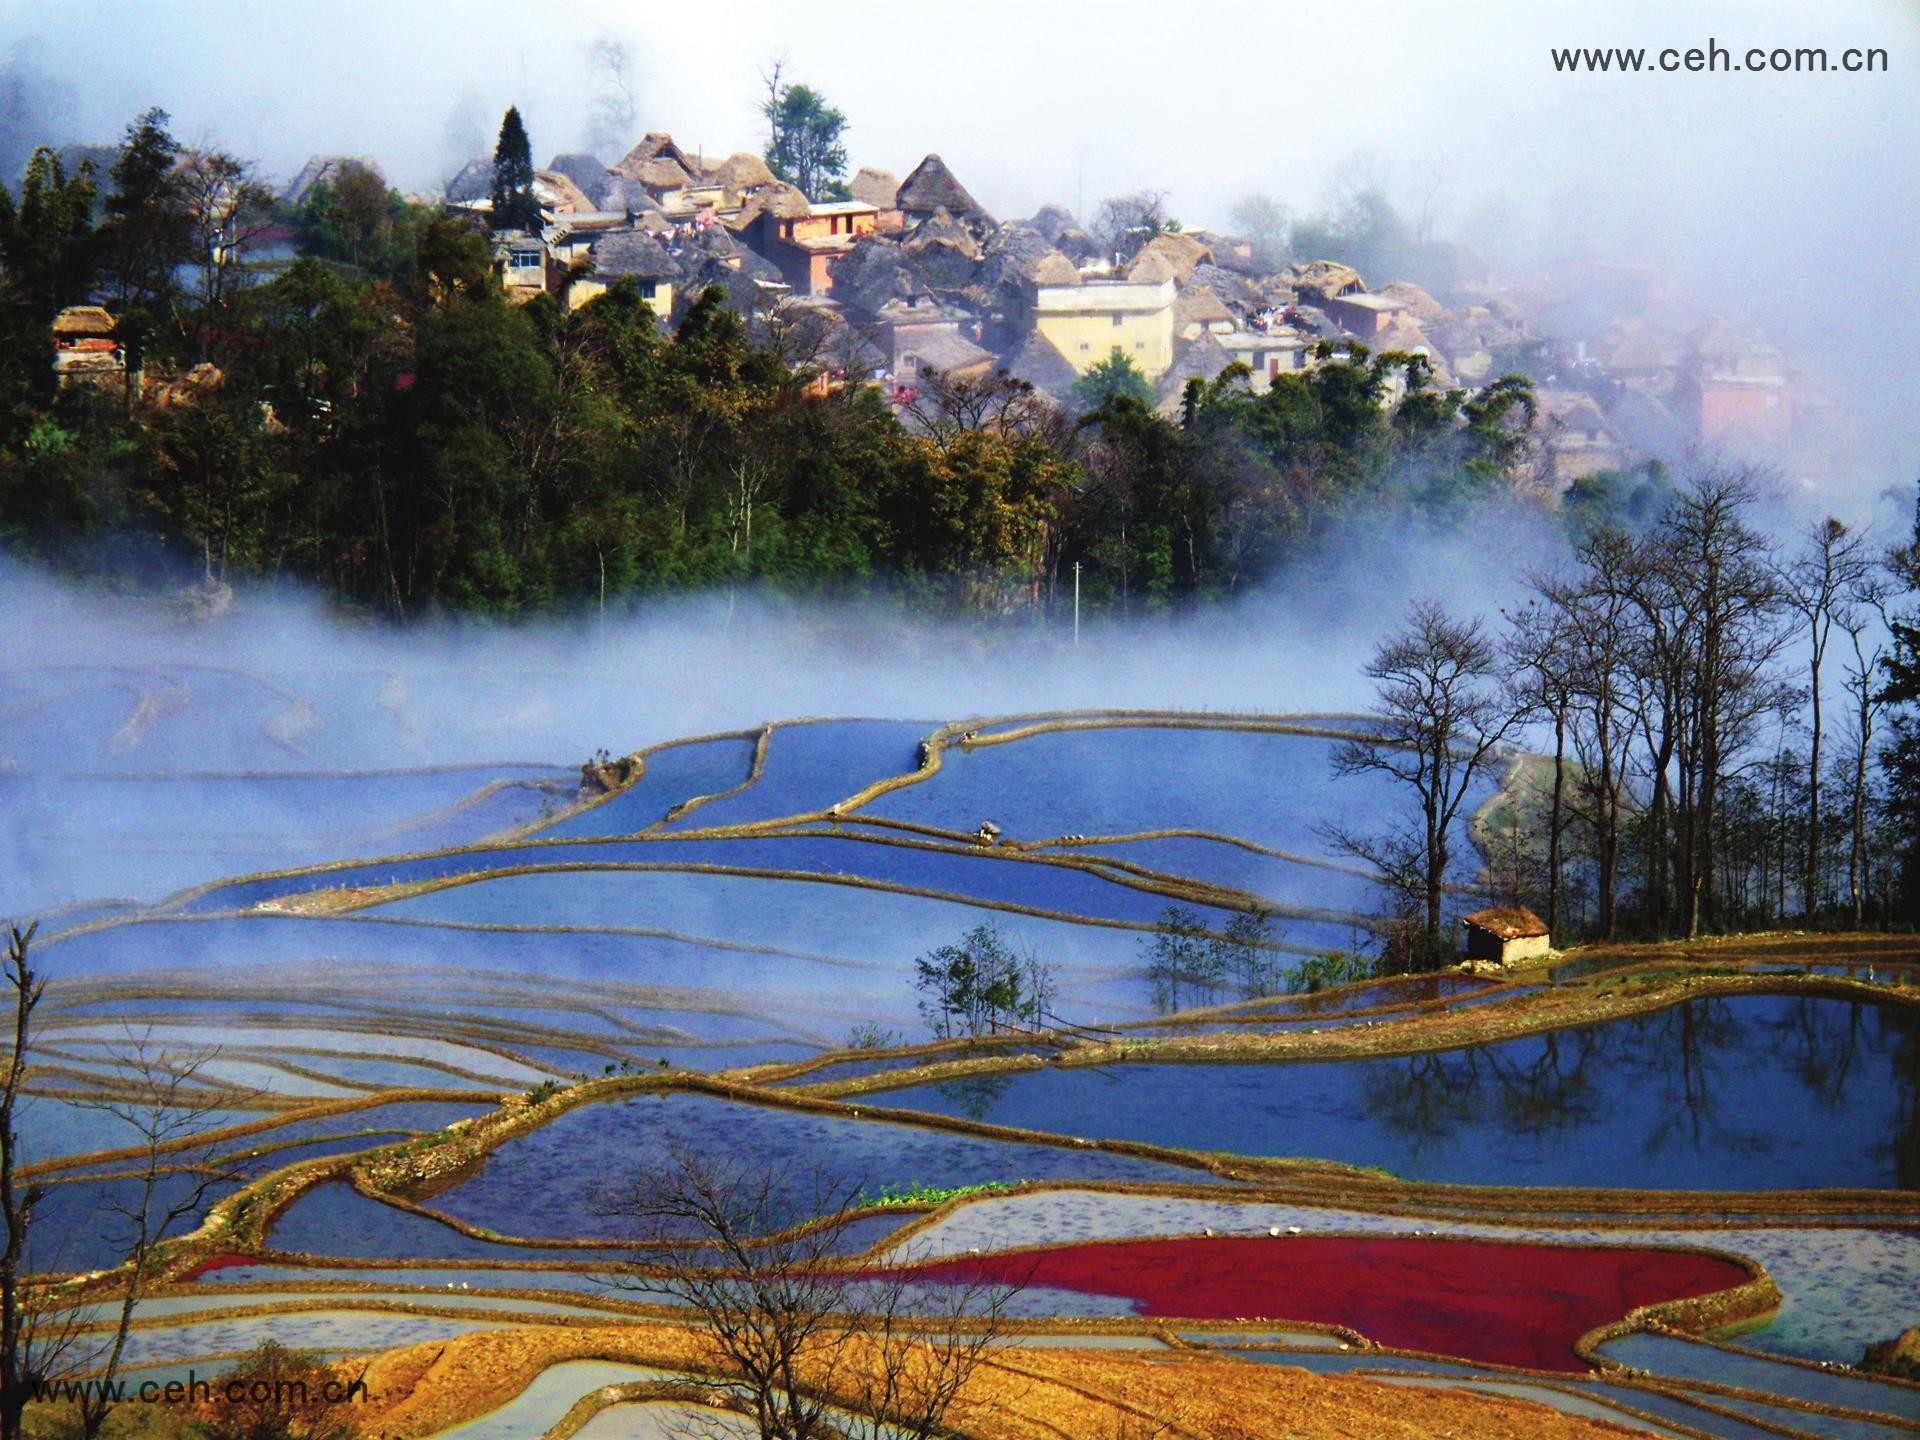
[[0, 679, 1920, 1440]]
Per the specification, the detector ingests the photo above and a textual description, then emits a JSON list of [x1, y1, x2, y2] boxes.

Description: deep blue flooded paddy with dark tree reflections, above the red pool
[[879, 995, 1920, 1190]]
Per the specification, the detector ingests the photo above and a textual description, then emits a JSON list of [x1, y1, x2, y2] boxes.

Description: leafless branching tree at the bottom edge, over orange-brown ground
[[597, 1144, 1014, 1440]]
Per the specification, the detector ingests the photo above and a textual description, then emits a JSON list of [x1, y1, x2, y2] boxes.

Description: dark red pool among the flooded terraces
[[916, 1235, 1749, 1371]]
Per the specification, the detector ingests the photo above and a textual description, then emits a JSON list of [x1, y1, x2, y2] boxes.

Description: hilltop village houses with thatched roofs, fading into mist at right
[[56, 132, 1793, 484]]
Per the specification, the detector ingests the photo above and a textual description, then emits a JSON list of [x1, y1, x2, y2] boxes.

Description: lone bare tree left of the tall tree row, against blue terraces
[[1334, 601, 1519, 956]]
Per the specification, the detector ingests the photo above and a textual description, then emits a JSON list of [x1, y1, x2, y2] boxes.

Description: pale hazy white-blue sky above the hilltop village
[[0, 0, 1920, 514]]
